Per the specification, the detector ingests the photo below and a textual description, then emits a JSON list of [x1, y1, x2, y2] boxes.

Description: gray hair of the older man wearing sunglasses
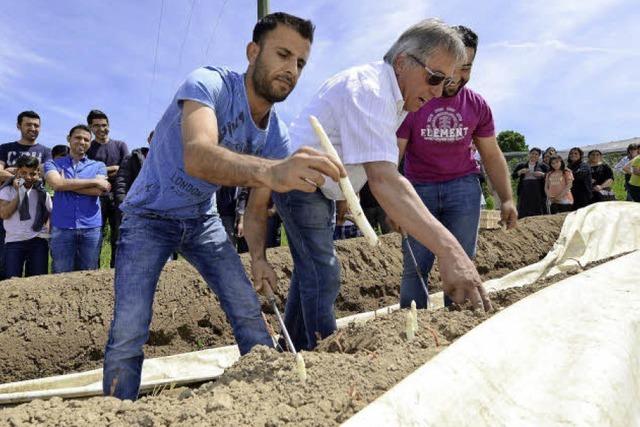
[[384, 19, 466, 65]]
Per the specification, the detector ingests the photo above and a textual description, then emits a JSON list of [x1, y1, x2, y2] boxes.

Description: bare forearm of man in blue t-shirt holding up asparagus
[[184, 143, 276, 187]]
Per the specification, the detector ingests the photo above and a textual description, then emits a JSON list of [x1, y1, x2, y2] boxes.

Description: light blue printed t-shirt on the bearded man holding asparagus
[[121, 67, 290, 219]]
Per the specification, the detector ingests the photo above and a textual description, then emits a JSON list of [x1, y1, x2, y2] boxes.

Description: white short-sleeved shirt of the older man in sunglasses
[[289, 61, 407, 200]]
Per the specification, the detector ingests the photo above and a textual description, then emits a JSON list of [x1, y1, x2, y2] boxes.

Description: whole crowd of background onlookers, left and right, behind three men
[[0, 110, 640, 279]]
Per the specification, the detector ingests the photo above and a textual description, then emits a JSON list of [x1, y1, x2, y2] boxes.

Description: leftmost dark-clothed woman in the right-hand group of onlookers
[[511, 148, 548, 218]]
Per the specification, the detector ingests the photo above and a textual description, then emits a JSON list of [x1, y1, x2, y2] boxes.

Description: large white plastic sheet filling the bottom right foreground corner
[[344, 251, 640, 427]]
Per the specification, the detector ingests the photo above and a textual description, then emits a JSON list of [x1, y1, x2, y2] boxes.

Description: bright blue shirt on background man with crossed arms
[[44, 156, 107, 229]]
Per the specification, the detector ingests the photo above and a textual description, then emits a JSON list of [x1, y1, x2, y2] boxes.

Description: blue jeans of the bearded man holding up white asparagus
[[103, 214, 273, 400]]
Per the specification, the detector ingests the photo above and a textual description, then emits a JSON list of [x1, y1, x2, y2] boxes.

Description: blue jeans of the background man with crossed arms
[[51, 227, 102, 273]]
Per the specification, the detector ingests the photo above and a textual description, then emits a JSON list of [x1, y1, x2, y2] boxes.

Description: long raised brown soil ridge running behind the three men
[[0, 215, 564, 383]]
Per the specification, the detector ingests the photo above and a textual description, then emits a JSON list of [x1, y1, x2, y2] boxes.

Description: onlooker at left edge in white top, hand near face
[[0, 155, 51, 277]]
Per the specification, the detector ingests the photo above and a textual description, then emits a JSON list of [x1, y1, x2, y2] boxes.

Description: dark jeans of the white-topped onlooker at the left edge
[[4, 237, 49, 278]]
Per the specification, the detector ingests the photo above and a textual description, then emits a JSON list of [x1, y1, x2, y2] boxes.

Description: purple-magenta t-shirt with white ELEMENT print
[[397, 87, 495, 184]]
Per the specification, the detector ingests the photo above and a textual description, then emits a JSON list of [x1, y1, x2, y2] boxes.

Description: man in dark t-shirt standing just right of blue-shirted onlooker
[[87, 110, 129, 268]]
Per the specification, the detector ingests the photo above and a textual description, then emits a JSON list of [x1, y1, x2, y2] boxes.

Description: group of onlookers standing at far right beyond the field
[[511, 144, 640, 218]]
